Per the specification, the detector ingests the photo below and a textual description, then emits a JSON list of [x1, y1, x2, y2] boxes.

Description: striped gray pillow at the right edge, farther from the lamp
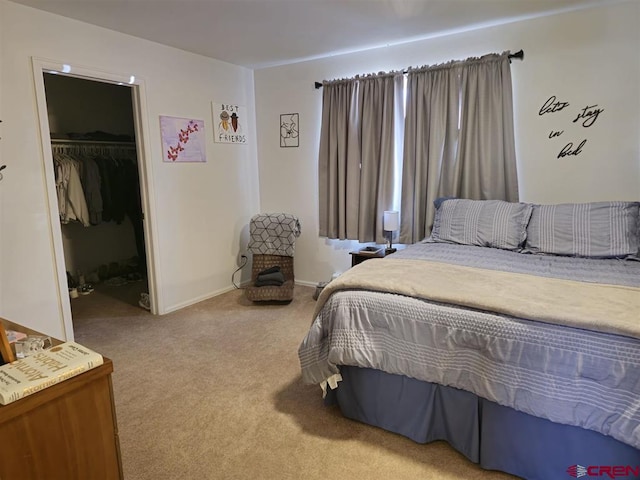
[[525, 202, 640, 258]]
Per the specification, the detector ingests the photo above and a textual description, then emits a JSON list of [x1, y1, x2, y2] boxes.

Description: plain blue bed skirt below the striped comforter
[[325, 366, 640, 480]]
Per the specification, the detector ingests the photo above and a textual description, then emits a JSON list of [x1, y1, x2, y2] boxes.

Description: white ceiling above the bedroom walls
[[11, 0, 619, 69]]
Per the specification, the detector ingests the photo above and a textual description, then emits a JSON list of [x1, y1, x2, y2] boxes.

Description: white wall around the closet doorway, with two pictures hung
[[0, 0, 259, 338]]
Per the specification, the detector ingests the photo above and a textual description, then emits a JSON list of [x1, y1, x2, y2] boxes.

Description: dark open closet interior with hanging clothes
[[43, 73, 148, 323]]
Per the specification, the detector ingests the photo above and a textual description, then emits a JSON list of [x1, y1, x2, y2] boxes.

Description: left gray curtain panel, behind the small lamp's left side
[[318, 73, 403, 243]]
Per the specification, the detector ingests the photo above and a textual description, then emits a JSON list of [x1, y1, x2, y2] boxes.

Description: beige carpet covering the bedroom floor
[[72, 284, 515, 480]]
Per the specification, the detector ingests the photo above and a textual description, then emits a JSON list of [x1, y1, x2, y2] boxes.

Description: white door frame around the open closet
[[31, 57, 162, 340]]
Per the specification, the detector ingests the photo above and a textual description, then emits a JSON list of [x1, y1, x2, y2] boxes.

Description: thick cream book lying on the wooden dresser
[[0, 342, 104, 405]]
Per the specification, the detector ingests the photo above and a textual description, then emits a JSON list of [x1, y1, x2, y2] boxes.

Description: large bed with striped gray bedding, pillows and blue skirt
[[298, 199, 640, 480]]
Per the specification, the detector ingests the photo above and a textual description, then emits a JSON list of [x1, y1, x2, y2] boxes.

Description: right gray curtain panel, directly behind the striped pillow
[[400, 52, 519, 243]]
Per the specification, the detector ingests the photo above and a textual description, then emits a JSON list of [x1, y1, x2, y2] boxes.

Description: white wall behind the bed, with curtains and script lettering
[[255, 1, 640, 283]]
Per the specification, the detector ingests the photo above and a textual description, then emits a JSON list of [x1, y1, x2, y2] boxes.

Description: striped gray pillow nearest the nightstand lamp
[[431, 199, 532, 250]]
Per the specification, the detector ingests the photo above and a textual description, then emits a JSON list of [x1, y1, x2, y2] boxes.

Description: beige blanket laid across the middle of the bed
[[314, 258, 640, 338]]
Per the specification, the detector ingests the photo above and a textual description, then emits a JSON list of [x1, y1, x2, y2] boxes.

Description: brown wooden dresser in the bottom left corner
[[0, 358, 123, 480]]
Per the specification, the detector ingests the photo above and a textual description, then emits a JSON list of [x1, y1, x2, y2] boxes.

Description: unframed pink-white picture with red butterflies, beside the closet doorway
[[160, 116, 207, 163]]
